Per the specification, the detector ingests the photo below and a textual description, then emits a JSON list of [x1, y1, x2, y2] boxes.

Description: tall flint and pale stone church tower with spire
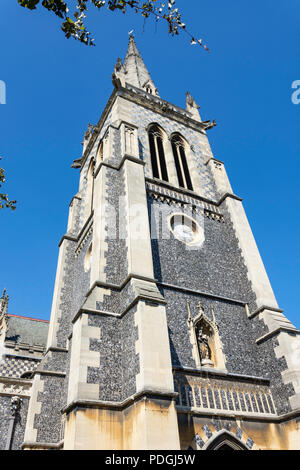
[[19, 36, 300, 450]]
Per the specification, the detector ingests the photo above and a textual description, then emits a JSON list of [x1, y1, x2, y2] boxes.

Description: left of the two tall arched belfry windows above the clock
[[148, 124, 169, 181]]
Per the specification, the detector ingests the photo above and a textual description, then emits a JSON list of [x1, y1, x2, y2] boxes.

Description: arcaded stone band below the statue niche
[[174, 372, 276, 416]]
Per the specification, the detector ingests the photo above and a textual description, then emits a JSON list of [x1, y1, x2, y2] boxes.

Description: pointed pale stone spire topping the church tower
[[124, 34, 158, 96]]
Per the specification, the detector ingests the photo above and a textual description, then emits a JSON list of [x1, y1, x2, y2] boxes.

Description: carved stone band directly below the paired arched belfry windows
[[146, 182, 224, 222]]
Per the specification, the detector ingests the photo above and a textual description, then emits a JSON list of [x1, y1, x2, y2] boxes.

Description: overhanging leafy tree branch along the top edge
[[18, 0, 209, 51]]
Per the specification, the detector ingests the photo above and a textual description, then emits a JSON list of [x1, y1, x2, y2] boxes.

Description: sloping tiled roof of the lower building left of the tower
[[5, 314, 49, 346]]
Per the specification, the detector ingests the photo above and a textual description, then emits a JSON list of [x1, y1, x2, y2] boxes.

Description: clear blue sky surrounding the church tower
[[0, 0, 300, 328]]
